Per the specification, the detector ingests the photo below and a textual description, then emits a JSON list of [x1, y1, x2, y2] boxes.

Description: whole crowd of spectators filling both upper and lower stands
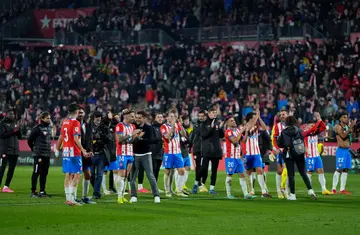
[[0, 0, 360, 140]]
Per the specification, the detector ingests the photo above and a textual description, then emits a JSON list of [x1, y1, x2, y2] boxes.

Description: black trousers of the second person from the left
[[31, 156, 50, 192]]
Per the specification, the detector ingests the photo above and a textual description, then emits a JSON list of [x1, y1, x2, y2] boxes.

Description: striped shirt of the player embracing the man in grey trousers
[[115, 122, 136, 156]]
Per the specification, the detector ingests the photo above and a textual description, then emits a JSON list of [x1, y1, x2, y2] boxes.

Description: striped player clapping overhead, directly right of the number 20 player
[[243, 111, 272, 198]]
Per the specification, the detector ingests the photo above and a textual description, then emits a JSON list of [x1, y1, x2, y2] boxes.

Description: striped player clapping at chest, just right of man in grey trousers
[[160, 111, 188, 197]]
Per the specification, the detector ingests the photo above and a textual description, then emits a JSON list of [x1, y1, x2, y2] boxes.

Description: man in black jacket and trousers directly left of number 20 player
[[199, 107, 224, 194]]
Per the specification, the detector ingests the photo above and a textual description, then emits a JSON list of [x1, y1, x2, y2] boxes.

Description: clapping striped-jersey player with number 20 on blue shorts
[[225, 116, 255, 199]]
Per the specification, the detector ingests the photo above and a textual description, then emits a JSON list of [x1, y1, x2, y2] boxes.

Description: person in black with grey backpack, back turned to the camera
[[276, 116, 317, 200]]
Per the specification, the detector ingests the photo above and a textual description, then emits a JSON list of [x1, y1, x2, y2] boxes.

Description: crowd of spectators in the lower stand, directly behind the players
[[0, 34, 360, 140]]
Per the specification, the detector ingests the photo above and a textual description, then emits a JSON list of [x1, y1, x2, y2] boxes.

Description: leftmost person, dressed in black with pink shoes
[[0, 107, 21, 193]]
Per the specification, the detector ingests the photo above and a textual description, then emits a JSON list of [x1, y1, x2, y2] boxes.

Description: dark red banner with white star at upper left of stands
[[34, 8, 96, 38]]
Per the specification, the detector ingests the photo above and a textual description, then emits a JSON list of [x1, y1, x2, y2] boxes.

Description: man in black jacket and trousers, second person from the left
[[28, 112, 52, 198]]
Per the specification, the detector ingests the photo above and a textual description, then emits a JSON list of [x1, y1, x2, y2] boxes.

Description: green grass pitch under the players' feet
[[0, 167, 360, 235]]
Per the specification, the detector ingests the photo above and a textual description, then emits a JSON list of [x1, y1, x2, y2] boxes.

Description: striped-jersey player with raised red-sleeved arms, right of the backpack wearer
[[303, 113, 332, 195]]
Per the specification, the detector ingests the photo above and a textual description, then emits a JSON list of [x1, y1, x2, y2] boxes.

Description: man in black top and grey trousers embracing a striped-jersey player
[[130, 111, 160, 203]]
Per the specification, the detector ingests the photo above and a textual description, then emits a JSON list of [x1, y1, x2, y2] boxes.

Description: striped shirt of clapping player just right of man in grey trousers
[[160, 123, 181, 154]]
